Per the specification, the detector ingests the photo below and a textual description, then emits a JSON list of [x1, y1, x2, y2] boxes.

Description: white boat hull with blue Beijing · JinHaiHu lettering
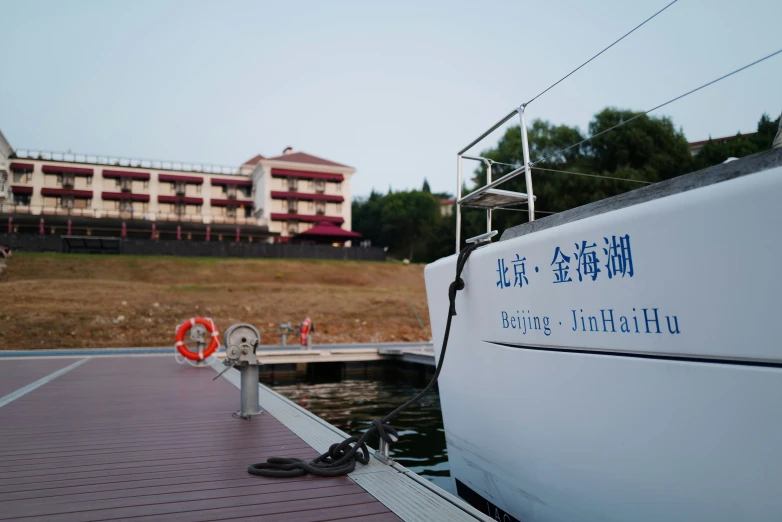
[[426, 160, 782, 522]]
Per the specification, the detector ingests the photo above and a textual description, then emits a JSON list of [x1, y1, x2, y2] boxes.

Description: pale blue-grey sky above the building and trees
[[0, 0, 782, 195]]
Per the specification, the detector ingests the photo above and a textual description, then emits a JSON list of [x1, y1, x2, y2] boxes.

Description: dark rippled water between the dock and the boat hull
[[261, 370, 455, 493]]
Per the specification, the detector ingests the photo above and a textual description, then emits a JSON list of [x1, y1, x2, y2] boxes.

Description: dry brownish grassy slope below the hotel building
[[0, 253, 430, 349]]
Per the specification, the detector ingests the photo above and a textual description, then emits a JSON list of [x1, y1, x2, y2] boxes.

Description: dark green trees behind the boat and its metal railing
[[353, 108, 779, 262]]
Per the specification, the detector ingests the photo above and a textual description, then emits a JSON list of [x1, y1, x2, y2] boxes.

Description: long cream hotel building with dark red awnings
[[0, 130, 355, 242]]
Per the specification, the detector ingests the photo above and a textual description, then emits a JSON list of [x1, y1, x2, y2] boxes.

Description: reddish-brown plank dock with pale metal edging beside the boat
[[0, 355, 490, 522]]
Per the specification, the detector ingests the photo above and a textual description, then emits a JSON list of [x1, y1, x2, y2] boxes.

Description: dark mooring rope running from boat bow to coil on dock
[[247, 240, 488, 477]]
